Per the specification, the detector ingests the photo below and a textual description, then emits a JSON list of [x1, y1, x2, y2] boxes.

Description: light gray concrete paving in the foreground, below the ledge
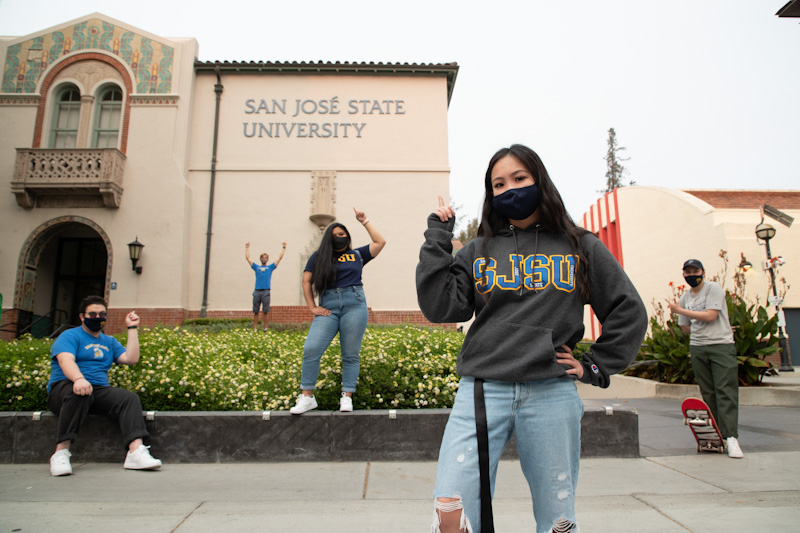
[[0, 374, 800, 533]]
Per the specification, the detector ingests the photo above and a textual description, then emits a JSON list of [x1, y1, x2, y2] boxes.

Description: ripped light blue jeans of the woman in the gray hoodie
[[431, 377, 583, 533]]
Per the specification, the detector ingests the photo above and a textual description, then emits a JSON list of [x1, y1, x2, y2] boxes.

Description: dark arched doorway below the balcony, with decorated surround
[[14, 216, 112, 337]]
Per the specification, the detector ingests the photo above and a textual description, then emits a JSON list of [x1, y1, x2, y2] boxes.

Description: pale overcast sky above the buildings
[[0, 0, 800, 221]]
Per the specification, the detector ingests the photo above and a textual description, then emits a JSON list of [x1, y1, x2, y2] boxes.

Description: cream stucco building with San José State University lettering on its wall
[[0, 13, 458, 338]]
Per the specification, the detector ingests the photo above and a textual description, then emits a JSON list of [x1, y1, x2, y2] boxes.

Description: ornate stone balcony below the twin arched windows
[[11, 148, 125, 208]]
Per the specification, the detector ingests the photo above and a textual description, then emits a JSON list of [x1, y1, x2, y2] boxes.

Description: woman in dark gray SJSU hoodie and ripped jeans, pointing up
[[417, 145, 647, 533]]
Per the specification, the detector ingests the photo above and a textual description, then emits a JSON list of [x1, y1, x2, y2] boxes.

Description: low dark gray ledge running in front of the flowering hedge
[[0, 408, 639, 463]]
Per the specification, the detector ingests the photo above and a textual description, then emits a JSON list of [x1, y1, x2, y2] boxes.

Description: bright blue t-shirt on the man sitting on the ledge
[[47, 326, 125, 393]]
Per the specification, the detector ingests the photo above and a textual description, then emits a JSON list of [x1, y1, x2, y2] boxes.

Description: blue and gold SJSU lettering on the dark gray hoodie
[[472, 254, 579, 293]]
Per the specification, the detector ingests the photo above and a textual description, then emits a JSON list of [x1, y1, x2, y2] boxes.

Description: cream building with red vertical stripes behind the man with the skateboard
[[580, 186, 800, 363]]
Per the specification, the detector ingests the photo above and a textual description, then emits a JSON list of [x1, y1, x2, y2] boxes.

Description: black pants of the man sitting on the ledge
[[47, 379, 150, 450]]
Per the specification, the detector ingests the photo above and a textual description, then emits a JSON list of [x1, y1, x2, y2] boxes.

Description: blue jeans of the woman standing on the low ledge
[[300, 285, 369, 392]]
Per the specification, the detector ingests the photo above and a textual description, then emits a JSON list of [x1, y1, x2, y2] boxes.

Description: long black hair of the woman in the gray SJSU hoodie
[[478, 144, 591, 301]]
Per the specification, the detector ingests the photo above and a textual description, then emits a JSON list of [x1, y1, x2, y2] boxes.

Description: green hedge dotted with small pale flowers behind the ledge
[[0, 326, 464, 411]]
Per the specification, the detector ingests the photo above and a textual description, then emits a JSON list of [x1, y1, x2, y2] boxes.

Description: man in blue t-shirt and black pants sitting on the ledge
[[47, 296, 161, 476]]
